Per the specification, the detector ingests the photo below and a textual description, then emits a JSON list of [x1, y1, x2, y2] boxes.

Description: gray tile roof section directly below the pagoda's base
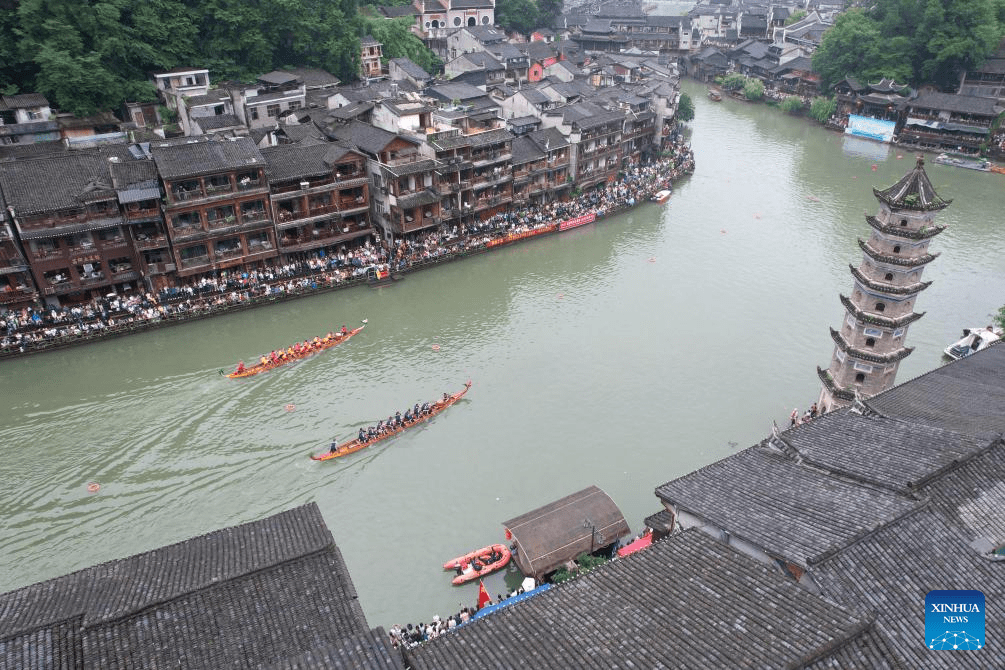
[[781, 409, 996, 494]]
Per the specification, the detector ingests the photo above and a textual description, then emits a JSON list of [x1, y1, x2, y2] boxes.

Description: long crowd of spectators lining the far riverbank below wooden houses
[[0, 143, 694, 355]]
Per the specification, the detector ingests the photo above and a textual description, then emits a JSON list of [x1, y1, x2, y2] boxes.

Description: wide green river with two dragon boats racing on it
[[0, 81, 1005, 627]]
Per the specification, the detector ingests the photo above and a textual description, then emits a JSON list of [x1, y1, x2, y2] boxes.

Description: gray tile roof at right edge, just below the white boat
[[866, 346, 1005, 435]]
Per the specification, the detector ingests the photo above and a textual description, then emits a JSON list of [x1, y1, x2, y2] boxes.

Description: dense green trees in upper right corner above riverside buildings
[[813, 0, 1005, 90]]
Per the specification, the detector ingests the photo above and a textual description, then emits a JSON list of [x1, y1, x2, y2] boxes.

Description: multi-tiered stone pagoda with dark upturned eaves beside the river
[[817, 157, 952, 412]]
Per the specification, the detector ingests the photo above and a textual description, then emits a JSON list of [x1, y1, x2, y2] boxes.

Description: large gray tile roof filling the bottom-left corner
[[0, 503, 395, 668]]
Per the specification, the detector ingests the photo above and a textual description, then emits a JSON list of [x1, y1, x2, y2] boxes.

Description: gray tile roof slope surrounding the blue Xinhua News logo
[[812, 509, 1005, 669]]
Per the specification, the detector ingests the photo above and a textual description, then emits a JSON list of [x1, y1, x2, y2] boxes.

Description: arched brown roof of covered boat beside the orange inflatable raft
[[503, 486, 630, 579]]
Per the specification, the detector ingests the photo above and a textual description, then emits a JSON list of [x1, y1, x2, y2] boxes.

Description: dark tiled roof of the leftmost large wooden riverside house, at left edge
[[0, 153, 115, 215]]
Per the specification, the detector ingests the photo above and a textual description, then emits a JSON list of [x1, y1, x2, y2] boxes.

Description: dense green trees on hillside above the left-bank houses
[[0, 0, 436, 116]]
